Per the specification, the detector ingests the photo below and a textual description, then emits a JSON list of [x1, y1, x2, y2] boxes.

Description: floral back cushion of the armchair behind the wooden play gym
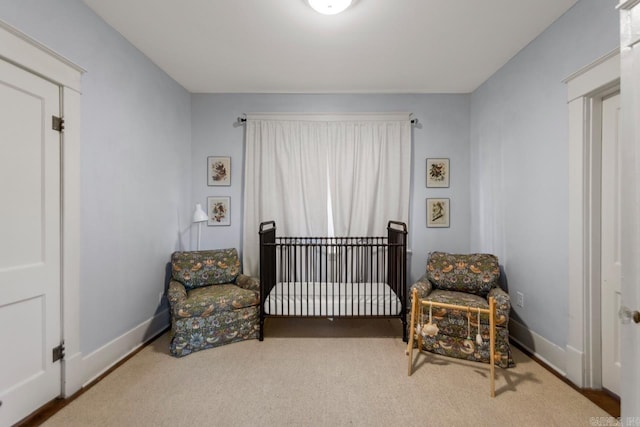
[[427, 252, 500, 296]]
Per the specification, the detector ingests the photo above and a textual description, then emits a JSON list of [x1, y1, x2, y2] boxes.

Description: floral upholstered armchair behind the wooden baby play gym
[[411, 252, 515, 368]]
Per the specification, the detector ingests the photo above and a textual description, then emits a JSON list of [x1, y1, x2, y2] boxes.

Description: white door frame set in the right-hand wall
[[564, 49, 620, 389]]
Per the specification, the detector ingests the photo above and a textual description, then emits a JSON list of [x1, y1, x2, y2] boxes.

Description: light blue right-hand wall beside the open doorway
[[470, 0, 619, 348]]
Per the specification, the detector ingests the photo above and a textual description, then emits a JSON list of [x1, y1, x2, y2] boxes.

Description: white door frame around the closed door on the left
[[0, 20, 84, 398]]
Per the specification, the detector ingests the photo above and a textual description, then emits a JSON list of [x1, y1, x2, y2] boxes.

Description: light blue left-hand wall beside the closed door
[[0, 0, 191, 355]]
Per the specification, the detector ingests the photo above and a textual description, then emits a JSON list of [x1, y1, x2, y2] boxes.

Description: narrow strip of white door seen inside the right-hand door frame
[[600, 94, 621, 395]]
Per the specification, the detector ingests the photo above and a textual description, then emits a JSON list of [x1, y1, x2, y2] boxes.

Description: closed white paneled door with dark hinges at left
[[0, 60, 62, 426]]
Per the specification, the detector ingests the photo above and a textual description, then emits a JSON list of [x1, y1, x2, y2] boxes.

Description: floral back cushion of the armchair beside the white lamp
[[171, 248, 240, 289]]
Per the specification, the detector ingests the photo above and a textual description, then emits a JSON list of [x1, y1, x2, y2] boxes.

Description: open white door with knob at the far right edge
[[620, 0, 640, 426]]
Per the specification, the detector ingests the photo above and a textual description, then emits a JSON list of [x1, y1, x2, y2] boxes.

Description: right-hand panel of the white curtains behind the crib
[[328, 115, 411, 237]]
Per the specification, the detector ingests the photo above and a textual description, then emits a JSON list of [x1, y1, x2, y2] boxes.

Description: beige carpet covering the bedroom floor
[[44, 319, 609, 427]]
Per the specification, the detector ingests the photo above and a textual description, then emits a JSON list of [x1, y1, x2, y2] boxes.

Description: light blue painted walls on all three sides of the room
[[0, 0, 618, 364]]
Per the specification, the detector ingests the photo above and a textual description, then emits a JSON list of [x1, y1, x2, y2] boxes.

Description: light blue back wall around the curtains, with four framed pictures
[[191, 94, 470, 283]]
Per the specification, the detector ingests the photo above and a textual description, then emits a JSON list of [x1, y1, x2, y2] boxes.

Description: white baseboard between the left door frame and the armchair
[[82, 310, 170, 387]]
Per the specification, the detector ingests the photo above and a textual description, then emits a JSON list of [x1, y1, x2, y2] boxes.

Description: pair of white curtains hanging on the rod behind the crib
[[243, 113, 411, 276]]
